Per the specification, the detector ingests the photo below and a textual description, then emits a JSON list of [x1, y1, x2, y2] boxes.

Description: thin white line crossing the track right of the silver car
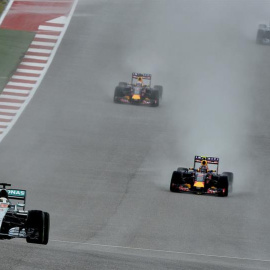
[[50, 240, 270, 262]]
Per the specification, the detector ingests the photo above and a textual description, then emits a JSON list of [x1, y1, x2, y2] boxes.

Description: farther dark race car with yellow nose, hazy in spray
[[114, 72, 163, 107]]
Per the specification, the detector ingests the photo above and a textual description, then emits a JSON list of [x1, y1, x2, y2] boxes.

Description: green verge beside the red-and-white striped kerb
[[0, 29, 35, 93]]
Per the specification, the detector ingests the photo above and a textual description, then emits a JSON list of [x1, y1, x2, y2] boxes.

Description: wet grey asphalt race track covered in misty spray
[[0, 0, 270, 270]]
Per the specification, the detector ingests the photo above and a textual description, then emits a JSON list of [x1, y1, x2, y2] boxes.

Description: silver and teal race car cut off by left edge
[[0, 183, 50, 245]]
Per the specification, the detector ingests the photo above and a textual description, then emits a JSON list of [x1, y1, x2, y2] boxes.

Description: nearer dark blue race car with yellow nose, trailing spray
[[170, 156, 233, 197]]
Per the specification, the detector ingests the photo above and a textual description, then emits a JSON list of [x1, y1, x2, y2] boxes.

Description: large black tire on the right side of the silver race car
[[25, 210, 50, 245]]
